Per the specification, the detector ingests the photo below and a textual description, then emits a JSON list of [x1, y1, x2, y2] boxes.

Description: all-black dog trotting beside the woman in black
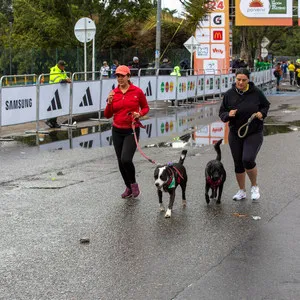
[[205, 139, 226, 204]]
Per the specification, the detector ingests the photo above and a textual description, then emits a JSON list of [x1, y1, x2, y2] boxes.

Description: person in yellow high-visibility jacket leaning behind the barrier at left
[[46, 60, 71, 128]]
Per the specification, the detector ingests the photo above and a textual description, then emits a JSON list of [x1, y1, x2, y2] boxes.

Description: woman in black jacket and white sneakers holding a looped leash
[[219, 69, 270, 200]]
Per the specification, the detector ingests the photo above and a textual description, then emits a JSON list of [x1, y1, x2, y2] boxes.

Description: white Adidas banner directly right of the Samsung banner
[[39, 84, 70, 120]]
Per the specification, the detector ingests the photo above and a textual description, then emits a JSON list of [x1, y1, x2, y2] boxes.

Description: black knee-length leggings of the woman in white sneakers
[[228, 132, 263, 173]]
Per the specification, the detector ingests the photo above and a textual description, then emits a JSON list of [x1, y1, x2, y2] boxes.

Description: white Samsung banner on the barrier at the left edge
[[0, 86, 36, 126]]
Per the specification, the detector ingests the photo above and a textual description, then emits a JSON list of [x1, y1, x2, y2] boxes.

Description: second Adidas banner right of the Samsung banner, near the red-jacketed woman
[[72, 81, 101, 114]]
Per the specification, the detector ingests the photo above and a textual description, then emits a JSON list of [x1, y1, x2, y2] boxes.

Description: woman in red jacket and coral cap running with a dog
[[104, 65, 149, 198]]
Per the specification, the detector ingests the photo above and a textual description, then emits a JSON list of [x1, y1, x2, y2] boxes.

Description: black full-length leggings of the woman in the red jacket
[[112, 127, 140, 188]]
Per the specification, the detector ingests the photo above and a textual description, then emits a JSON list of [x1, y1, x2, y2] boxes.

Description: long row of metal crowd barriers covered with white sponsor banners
[[0, 69, 274, 131]]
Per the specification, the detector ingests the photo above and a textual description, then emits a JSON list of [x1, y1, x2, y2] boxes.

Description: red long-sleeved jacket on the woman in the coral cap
[[104, 83, 149, 129]]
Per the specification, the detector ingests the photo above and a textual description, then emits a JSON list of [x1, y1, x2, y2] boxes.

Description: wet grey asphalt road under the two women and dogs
[[0, 94, 300, 300]]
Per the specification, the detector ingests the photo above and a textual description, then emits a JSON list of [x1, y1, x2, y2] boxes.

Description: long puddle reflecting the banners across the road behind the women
[[1, 101, 300, 151]]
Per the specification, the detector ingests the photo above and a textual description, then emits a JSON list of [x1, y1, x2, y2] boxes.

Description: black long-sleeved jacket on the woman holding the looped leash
[[219, 82, 270, 135]]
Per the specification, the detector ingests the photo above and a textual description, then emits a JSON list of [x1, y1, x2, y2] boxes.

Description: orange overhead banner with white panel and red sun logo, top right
[[235, 0, 293, 26]]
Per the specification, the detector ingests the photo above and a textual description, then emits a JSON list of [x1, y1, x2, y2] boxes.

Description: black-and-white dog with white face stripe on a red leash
[[154, 150, 187, 218]]
